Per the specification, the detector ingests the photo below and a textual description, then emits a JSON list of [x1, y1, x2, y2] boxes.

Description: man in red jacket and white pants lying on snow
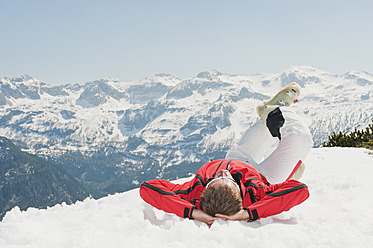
[[140, 83, 312, 226]]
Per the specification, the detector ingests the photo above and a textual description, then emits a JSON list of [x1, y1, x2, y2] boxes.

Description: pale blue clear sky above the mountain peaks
[[0, 0, 373, 84]]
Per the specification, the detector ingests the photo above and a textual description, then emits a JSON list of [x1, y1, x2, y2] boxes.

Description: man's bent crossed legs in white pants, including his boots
[[226, 83, 313, 183]]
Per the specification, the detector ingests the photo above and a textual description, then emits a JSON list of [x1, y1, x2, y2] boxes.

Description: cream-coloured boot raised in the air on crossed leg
[[256, 83, 300, 121]]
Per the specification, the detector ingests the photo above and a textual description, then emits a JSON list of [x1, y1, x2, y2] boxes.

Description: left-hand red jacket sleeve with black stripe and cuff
[[140, 179, 196, 219]]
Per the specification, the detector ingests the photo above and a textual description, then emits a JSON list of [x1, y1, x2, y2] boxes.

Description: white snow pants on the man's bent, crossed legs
[[226, 107, 313, 184]]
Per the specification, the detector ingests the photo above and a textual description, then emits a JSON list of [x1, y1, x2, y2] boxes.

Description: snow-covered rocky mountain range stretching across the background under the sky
[[0, 66, 373, 196]]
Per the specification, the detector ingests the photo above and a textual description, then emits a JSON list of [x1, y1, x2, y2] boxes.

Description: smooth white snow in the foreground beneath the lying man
[[0, 148, 373, 248]]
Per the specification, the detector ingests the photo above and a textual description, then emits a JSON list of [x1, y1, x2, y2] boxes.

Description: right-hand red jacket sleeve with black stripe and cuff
[[245, 180, 309, 221]]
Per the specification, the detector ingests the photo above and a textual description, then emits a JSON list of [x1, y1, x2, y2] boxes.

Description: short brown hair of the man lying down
[[199, 180, 242, 216]]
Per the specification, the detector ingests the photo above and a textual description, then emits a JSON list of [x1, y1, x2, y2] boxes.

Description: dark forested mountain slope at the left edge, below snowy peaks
[[0, 137, 89, 220]]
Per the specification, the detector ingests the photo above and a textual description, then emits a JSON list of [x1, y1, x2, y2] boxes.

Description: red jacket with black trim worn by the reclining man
[[140, 159, 309, 221]]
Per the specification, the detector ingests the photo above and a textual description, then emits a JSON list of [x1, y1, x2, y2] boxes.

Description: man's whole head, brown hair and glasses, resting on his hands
[[200, 170, 242, 216]]
